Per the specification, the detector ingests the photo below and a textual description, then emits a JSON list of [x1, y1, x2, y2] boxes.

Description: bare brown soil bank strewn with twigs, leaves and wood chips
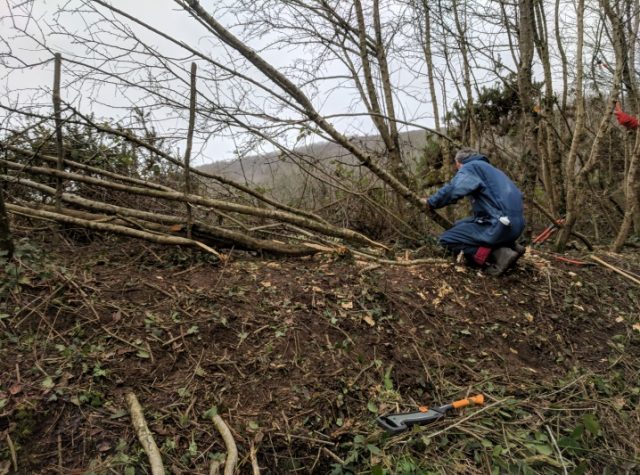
[[0, 230, 640, 474]]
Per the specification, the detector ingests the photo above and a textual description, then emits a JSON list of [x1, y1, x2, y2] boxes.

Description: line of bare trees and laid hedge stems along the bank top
[[0, 0, 640, 258]]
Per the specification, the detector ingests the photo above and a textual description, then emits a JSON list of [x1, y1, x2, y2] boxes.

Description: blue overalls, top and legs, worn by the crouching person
[[427, 155, 525, 262]]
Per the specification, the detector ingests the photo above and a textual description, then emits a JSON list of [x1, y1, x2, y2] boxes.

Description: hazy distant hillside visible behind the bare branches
[[198, 130, 427, 187]]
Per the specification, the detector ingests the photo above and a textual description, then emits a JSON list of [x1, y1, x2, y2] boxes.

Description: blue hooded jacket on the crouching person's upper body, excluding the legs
[[427, 154, 524, 228]]
